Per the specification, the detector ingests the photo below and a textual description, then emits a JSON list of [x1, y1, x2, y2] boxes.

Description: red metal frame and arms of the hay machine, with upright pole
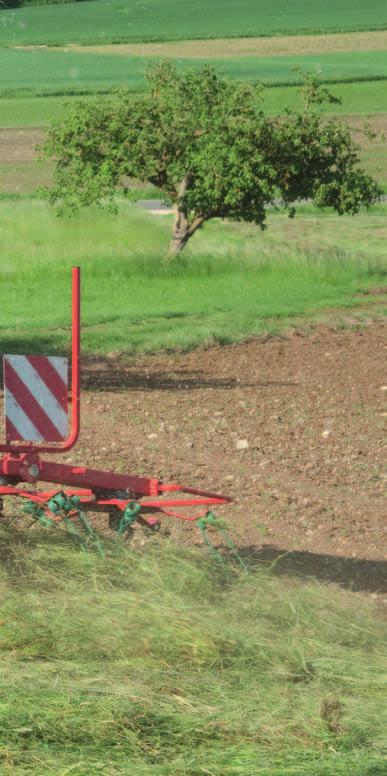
[[0, 267, 231, 525]]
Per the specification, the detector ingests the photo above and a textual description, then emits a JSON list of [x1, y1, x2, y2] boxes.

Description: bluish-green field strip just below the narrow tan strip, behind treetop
[[0, 45, 387, 96]]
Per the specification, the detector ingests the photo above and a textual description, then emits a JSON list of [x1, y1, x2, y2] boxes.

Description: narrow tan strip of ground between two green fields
[[17, 30, 387, 59]]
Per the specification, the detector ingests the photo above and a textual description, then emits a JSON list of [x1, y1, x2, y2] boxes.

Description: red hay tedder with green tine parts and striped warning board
[[0, 267, 231, 546]]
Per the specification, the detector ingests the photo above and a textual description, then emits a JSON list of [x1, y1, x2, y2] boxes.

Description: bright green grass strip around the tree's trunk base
[[0, 200, 386, 353]]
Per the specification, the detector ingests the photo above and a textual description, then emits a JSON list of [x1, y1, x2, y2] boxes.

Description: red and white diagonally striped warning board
[[4, 356, 68, 442]]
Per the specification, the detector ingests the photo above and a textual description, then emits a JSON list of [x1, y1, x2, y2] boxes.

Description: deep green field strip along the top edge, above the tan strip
[[0, 0, 387, 45]]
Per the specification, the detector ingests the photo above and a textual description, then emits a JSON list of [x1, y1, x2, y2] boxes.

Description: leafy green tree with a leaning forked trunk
[[43, 62, 381, 256]]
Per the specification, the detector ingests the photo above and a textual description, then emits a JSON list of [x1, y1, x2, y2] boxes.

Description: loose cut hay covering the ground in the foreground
[[0, 528, 387, 776]]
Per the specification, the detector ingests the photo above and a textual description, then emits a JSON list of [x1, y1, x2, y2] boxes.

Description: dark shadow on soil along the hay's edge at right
[[238, 545, 387, 593]]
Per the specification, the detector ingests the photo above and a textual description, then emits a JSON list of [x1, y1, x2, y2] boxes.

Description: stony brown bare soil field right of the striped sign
[[50, 323, 387, 592]]
